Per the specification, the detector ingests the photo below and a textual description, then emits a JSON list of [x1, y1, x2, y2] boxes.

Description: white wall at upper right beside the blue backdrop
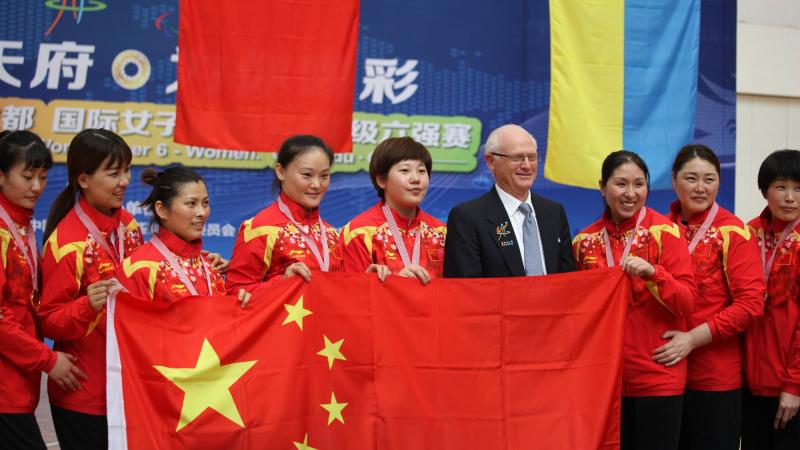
[[735, 0, 800, 220]]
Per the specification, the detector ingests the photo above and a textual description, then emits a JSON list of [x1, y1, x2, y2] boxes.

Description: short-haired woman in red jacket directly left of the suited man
[[342, 137, 447, 284]]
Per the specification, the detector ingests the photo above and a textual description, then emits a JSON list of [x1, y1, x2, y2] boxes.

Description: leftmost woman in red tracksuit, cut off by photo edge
[[0, 131, 84, 450]]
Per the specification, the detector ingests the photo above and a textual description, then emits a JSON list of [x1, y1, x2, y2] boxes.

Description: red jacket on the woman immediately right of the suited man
[[572, 209, 697, 397]]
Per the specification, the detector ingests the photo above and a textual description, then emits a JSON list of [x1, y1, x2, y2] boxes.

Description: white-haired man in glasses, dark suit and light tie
[[444, 125, 576, 278]]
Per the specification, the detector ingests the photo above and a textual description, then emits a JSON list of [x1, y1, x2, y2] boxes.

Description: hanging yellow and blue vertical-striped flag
[[545, 0, 700, 188]]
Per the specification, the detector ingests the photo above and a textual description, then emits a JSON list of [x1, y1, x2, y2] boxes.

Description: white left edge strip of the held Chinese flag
[[106, 279, 128, 450]]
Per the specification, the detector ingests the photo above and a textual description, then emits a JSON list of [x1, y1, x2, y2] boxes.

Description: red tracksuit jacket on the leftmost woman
[[0, 193, 57, 414]]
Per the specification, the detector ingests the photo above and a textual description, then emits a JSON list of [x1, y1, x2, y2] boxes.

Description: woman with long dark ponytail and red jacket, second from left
[[38, 129, 142, 450]]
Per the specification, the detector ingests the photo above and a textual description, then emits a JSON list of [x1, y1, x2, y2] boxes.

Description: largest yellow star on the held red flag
[[153, 339, 258, 431]]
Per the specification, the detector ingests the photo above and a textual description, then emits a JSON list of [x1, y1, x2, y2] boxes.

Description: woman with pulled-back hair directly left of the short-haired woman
[[227, 135, 342, 294]]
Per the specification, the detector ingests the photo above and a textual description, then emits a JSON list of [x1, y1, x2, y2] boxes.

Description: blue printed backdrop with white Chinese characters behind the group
[[0, 0, 736, 255]]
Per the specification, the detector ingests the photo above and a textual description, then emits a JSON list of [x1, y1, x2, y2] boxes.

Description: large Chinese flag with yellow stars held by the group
[[108, 268, 630, 450]]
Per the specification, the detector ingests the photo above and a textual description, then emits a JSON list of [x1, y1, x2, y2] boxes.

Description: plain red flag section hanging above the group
[[175, 0, 359, 152]]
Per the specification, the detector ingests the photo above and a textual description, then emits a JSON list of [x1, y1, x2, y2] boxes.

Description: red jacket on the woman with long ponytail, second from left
[[39, 197, 142, 415]]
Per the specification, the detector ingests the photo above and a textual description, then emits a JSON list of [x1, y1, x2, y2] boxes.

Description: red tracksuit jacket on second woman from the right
[[670, 202, 765, 391]]
